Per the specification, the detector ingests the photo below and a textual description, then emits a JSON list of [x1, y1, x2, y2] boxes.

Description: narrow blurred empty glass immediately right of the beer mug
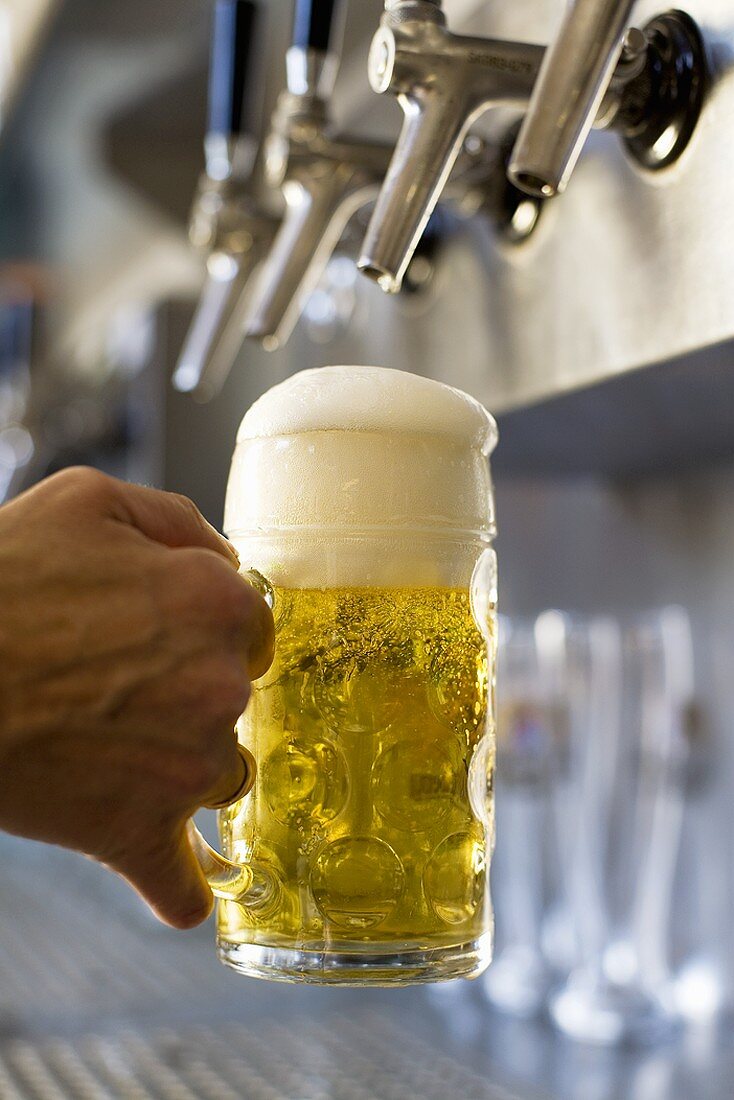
[[483, 612, 568, 1016]]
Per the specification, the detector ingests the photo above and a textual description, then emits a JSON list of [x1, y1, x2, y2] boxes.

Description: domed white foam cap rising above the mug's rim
[[238, 366, 497, 454]]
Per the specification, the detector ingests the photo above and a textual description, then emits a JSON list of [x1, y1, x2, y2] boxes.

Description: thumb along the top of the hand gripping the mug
[[107, 482, 239, 567]]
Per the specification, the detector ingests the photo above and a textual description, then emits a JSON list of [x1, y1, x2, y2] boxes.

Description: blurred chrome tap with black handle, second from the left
[[247, 0, 392, 350]]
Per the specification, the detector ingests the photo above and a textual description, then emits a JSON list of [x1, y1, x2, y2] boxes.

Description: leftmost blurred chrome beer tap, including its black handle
[[173, 0, 280, 402]]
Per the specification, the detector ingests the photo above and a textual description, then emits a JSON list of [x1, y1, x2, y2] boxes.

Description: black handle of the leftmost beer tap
[[209, 0, 259, 138]]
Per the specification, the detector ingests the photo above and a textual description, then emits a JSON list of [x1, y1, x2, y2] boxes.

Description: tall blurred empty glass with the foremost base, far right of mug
[[549, 607, 693, 1044]]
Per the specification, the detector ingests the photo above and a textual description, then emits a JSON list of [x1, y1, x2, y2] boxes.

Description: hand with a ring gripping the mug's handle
[[0, 469, 274, 928]]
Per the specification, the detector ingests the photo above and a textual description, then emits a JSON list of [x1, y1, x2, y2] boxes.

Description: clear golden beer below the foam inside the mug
[[219, 587, 489, 953]]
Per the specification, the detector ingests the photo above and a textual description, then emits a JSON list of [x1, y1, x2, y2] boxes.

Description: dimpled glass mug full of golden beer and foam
[[189, 367, 496, 986]]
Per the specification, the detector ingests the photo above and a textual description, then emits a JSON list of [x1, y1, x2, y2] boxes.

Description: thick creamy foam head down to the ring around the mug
[[224, 366, 496, 563]]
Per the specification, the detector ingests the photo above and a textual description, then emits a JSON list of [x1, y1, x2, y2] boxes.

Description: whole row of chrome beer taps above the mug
[[174, 0, 708, 400]]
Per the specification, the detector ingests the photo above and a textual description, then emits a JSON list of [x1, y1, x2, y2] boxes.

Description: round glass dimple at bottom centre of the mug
[[311, 836, 405, 928]]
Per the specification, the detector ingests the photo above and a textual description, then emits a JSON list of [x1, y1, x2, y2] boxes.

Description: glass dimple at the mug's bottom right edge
[[424, 832, 486, 924]]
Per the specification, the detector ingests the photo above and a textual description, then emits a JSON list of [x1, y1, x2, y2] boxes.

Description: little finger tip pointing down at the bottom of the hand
[[112, 825, 213, 930]]
